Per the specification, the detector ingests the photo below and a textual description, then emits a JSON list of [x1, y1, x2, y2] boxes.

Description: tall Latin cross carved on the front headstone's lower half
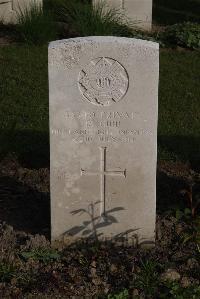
[[81, 147, 126, 217]]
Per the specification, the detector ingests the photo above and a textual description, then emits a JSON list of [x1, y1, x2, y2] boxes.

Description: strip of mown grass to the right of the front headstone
[[158, 50, 200, 166]]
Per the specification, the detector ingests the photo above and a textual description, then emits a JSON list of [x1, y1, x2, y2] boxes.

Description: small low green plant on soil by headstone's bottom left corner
[[20, 248, 60, 263]]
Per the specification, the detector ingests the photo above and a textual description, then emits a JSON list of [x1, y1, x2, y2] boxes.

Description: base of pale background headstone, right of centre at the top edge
[[93, 0, 152, 30]]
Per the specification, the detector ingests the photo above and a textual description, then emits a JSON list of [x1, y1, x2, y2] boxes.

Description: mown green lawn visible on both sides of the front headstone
[[0, 45, 200, 168]]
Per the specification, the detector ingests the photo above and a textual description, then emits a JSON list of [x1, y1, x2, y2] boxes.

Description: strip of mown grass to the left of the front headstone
[[0, 46, 49, 167]]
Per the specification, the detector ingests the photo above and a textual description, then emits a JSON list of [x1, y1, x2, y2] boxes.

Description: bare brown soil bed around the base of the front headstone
[[0, 156, 200, 298]]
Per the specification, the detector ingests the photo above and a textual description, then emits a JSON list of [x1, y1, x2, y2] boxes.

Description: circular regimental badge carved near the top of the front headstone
[[78, 57, 129, 106]]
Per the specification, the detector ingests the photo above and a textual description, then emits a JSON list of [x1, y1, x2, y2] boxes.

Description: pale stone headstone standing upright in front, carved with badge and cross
[[49, 37, 159, 243]]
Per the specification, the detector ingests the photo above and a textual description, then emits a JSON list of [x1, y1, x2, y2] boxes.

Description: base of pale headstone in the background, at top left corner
[[0, 0, 43, 23]]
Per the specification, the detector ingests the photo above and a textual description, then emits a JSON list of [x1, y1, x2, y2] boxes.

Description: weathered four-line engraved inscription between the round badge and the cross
[[50, 110, 153, 145]]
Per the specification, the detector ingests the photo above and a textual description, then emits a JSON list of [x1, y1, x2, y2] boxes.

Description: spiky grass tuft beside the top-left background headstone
[[16, 2, 57, 44]]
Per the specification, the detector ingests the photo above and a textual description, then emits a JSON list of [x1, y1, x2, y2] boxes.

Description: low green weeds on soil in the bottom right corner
[[159, 281, 200, 299]]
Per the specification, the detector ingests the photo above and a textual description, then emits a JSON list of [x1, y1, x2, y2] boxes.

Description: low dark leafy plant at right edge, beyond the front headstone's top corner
[[159, 22, 200, 49]]
